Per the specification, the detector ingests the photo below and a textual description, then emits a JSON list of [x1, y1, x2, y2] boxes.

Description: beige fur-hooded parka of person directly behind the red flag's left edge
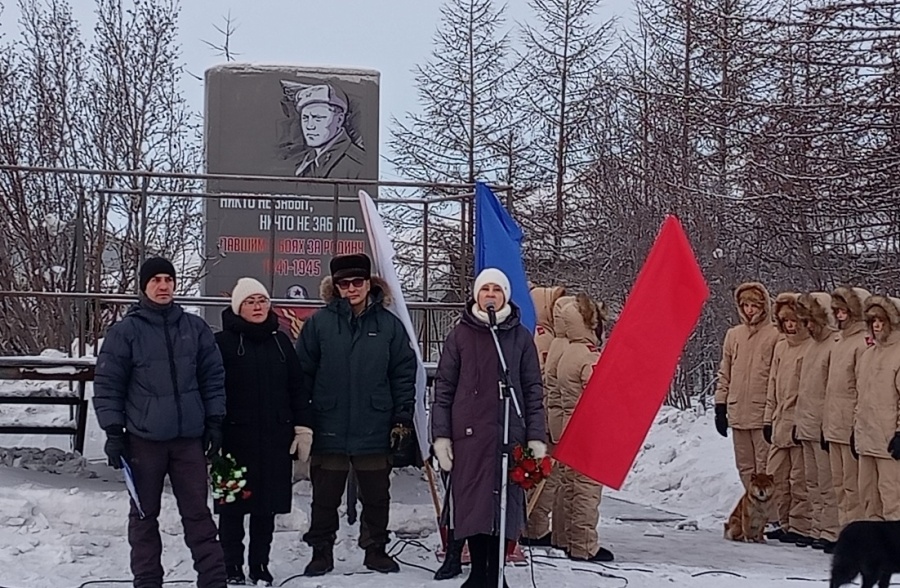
[[557, 294, 603, 430]]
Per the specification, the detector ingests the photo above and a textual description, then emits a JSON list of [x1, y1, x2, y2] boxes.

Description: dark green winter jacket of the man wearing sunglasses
[[297, 277, 417, 455]]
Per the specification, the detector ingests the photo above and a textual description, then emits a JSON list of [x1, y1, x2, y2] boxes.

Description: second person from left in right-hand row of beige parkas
[[763, 292, 812, 544]]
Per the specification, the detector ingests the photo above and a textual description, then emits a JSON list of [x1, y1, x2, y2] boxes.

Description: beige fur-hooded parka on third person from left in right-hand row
[[795, 292, 838, 442]]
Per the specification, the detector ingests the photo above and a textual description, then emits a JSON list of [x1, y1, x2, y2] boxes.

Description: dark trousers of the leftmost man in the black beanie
[[128, 435, 225, 588]]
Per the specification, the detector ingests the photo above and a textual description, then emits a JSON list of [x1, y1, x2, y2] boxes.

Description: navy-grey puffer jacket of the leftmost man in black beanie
[[94, 299, 225, 441]]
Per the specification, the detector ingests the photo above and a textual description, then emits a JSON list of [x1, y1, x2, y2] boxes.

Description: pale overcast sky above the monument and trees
[[0, 0, 633, 178]]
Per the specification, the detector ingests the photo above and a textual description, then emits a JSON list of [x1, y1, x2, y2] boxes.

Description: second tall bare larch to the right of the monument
[[516, 0, 613, 278]]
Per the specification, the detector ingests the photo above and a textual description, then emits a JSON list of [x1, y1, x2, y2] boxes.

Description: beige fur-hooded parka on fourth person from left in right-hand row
[[822, 286, 871, 445]]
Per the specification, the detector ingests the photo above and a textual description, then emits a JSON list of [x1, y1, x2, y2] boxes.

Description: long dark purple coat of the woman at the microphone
[[431, 302, 546, 539]]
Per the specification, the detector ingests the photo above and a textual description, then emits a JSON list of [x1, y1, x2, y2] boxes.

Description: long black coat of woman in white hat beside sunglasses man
[[215, 308, 312, 514]]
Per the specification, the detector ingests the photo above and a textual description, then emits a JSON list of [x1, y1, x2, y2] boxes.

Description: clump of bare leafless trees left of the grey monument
[[0, 0, 203, 352]]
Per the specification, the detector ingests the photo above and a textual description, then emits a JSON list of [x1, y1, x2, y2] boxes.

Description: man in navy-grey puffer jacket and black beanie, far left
[[94, 257, 226, 588]]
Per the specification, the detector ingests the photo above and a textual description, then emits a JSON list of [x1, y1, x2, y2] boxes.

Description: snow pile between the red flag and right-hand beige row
[[608, 406, 744, 529]]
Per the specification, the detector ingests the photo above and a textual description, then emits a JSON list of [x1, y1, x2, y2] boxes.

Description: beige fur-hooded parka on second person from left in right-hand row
[[765, 292, 809, 449]]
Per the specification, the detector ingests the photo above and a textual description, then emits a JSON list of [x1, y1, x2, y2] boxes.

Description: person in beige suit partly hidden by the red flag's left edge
[[557, 294, 613, 561]]
